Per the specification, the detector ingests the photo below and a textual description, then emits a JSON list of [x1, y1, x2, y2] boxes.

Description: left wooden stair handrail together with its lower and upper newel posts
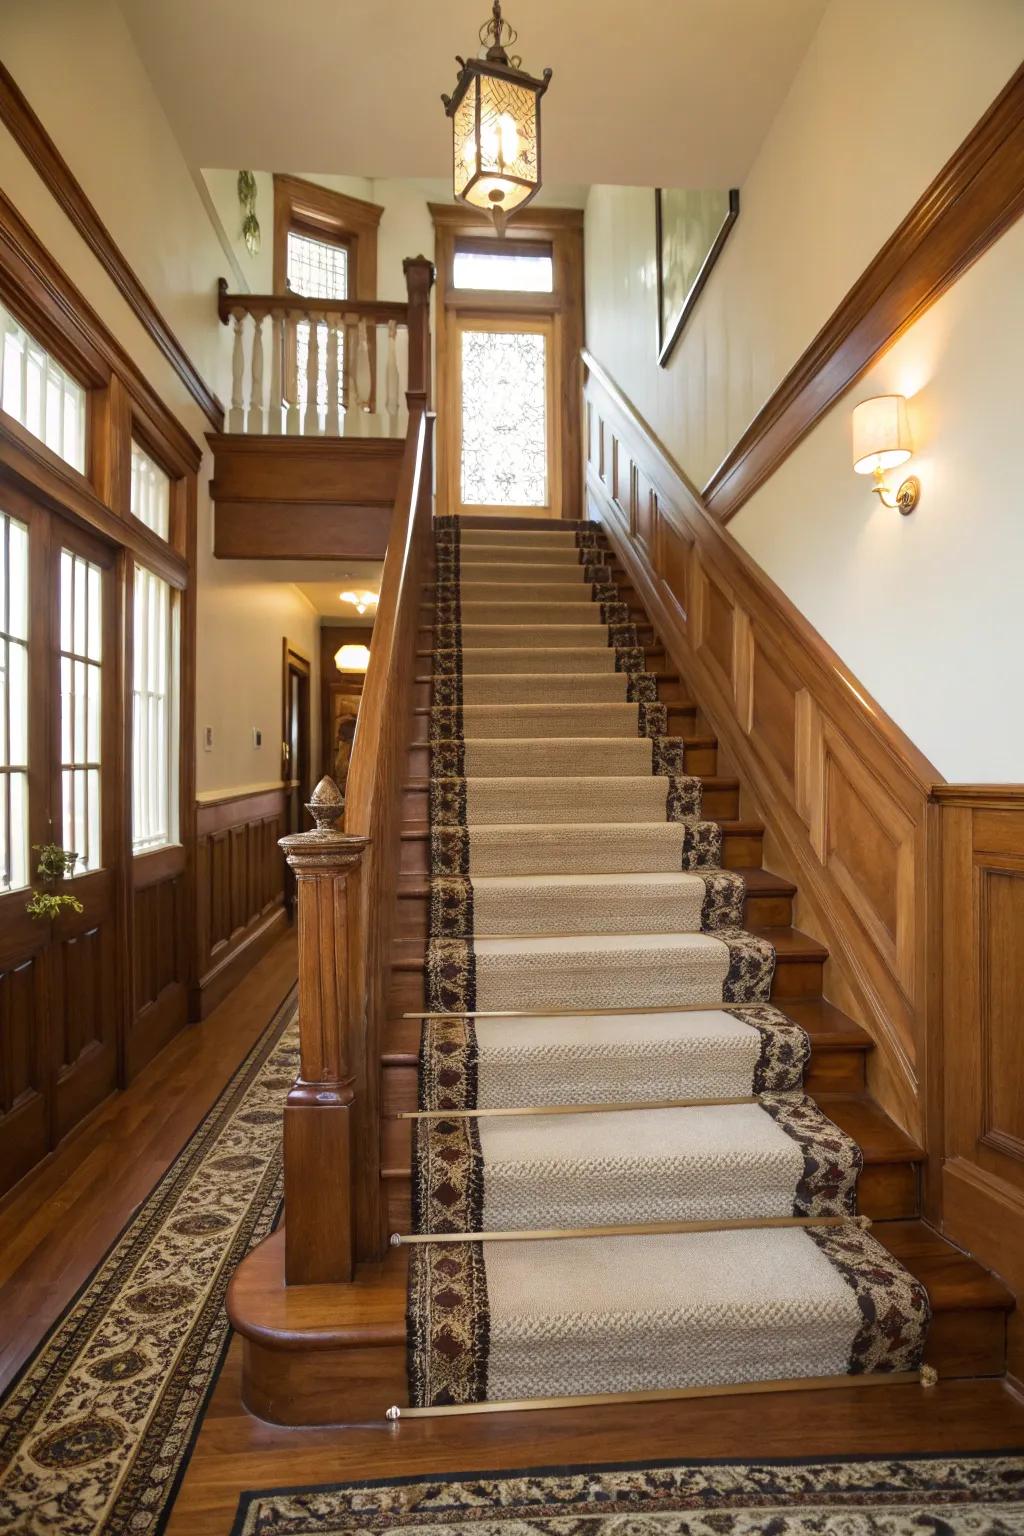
[[282, 258, 433, 1284]]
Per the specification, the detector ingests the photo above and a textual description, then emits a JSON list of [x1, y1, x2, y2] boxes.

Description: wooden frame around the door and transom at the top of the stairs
[[428, 203, 583, 518]]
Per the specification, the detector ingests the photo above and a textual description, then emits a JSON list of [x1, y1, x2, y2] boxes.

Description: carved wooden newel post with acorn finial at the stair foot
[[279, 779, 368, 1286]]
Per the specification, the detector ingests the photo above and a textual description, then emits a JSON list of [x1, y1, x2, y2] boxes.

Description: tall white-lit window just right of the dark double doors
[[132, 565, 178, 854]]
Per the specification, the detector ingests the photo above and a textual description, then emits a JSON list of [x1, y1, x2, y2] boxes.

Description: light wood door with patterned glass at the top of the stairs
[[448, 312, 562, 518]]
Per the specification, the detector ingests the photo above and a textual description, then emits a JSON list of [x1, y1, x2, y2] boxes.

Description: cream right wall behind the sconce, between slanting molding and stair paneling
[[729, 221, 1024, 783]]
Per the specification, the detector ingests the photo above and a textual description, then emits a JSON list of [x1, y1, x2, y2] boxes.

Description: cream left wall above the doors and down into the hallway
[[0, 0, 328, 793]]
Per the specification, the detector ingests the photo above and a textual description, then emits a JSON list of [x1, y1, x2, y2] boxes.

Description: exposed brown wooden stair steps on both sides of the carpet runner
[[229, 519, 1013, 1425]]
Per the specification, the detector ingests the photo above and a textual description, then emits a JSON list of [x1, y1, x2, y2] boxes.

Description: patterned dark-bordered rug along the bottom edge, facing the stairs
[[232, 1455, 1024, 1536]]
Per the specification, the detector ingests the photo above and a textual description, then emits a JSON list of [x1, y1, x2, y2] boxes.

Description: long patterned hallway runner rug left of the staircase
[[0, 997, 298, 1536]]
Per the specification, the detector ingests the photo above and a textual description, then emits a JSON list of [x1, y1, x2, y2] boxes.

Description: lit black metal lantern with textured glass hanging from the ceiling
[[441, 0, 551, 235]]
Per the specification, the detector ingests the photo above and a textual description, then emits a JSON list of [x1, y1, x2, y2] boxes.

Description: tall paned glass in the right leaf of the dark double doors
[[58, 550, 103, 874]]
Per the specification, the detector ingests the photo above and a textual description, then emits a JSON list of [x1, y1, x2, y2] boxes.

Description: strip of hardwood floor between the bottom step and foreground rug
[[166, 1357, 1024, 1536]]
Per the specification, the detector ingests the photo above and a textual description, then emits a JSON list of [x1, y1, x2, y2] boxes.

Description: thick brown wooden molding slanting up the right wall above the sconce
[[702, 65, 1024, 522]]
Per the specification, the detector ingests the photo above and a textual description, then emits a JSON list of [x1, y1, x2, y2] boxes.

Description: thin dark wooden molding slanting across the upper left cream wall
[[0, 63, 224, 432]]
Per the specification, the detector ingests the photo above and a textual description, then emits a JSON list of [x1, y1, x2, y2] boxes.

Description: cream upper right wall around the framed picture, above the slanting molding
[[586, 0, 1024, 485]]
